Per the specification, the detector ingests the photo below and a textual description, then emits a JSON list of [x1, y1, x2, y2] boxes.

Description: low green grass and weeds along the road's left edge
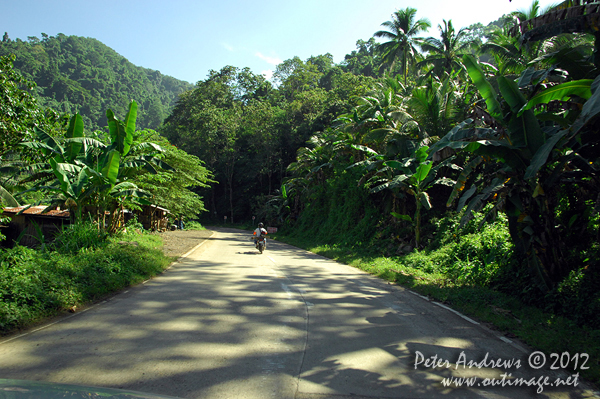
[[0, 224, 172, 335]]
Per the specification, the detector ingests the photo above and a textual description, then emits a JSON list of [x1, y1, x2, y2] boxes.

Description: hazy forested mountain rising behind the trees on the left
[[0, 33, 193, 130]]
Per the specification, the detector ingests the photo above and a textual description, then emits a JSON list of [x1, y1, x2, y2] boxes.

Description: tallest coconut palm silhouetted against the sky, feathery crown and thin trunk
[[374, 7, 431, 85]]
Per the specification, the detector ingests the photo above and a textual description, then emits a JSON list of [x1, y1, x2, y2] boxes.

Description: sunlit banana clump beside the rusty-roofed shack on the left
[[23, 101, 172, 231]]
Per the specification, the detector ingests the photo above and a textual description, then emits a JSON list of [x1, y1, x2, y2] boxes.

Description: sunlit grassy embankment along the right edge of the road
[[274, 214, 600, 385]]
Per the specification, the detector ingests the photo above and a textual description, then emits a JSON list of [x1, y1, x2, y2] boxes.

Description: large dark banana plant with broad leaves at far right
[[431, 56, 600, 290]]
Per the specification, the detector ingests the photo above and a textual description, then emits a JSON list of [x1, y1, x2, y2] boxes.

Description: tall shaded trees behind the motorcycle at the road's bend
[[161, 61, 371, 221]]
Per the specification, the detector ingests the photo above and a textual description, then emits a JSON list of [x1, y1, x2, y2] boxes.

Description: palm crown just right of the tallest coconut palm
[[417, 20, 470, 79]]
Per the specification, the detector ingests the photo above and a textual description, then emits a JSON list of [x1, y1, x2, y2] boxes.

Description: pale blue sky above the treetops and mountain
[[0, 0, 556, 83]]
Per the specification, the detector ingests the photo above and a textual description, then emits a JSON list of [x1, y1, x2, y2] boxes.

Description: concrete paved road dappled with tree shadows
[[0, 229, 591, 399]]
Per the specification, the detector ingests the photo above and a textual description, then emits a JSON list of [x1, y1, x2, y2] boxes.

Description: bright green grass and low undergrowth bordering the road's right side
[[274, 220, 600, 385]]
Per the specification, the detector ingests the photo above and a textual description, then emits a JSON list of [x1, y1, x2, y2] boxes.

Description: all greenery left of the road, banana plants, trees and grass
[[0, 51, 211, 335]]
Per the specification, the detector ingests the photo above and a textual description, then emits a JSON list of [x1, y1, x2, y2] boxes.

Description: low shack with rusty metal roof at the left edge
[[2, 205, 71, 247]]
